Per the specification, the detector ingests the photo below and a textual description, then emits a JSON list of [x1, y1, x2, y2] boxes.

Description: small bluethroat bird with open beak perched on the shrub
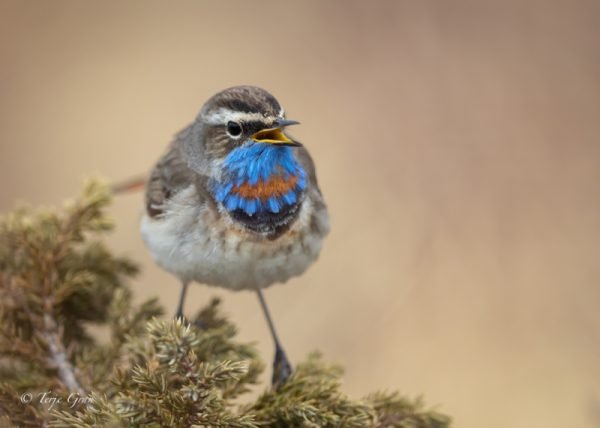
[[140, 86, 330, 386]]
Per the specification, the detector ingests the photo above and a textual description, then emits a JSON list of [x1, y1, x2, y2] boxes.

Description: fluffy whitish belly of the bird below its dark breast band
[[141, 188, 328, 290]]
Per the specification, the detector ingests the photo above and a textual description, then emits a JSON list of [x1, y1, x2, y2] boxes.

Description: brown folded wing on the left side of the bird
[[146, 125, 195, 218]]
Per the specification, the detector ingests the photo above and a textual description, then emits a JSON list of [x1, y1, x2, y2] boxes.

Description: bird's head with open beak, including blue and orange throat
[[185, 86, 306, 221]]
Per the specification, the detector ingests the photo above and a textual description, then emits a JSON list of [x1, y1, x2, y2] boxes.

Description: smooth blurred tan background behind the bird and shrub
[[0, 0, 600, 428]]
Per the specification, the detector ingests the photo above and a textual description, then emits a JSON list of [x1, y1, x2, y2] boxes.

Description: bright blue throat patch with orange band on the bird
[[213, 140, 306, 216]]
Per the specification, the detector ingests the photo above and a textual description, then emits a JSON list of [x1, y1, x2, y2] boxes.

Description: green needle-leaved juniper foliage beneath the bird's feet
[[0, 182, 450, 428]]
